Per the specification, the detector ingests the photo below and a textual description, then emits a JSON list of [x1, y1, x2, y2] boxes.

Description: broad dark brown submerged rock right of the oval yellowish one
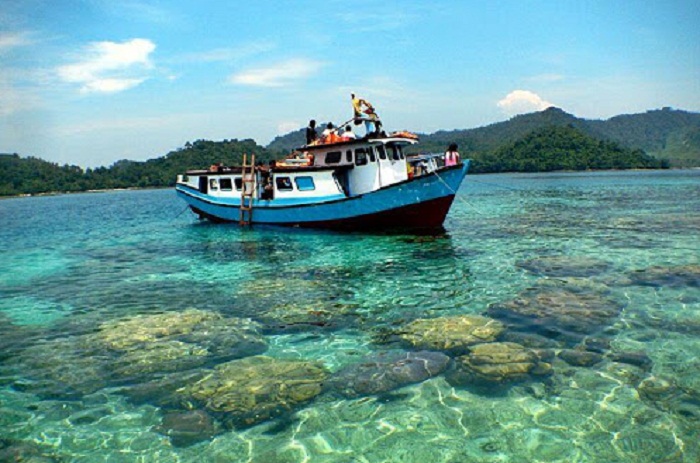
[[488, 288, 623, 342]]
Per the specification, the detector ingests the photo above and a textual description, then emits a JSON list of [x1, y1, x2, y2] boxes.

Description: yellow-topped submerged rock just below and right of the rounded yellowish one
[[447, 342, 552, 385]]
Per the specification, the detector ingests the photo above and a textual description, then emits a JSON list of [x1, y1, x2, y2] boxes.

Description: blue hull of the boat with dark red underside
[[176, 161, 469, 230]]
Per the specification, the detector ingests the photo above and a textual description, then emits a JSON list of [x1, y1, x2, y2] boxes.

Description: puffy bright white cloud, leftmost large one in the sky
[[57, 39, 156, 93]]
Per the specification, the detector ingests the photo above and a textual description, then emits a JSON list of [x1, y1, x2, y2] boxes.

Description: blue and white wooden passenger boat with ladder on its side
[[175, 122, 469, 231]]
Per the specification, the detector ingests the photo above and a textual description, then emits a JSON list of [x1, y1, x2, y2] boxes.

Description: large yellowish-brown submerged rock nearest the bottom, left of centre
[[178, 356, 328, 428]]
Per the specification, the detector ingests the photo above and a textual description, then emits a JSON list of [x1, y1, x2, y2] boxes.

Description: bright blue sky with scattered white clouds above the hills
[[0, 0, 700, 168]]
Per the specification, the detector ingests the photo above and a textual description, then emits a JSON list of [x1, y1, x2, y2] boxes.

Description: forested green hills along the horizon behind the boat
[[0, 107, 700, 196]]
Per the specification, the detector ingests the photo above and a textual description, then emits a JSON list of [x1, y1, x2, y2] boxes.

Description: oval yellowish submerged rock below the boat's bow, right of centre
[[398, 315, 504, 353]]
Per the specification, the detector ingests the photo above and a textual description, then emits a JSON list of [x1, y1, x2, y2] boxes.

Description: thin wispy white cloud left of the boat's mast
[[229, 59, 323, 87]]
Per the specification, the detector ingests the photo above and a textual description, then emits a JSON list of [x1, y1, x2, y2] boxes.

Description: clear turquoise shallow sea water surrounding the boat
[[0, 171, 700, 463]]
